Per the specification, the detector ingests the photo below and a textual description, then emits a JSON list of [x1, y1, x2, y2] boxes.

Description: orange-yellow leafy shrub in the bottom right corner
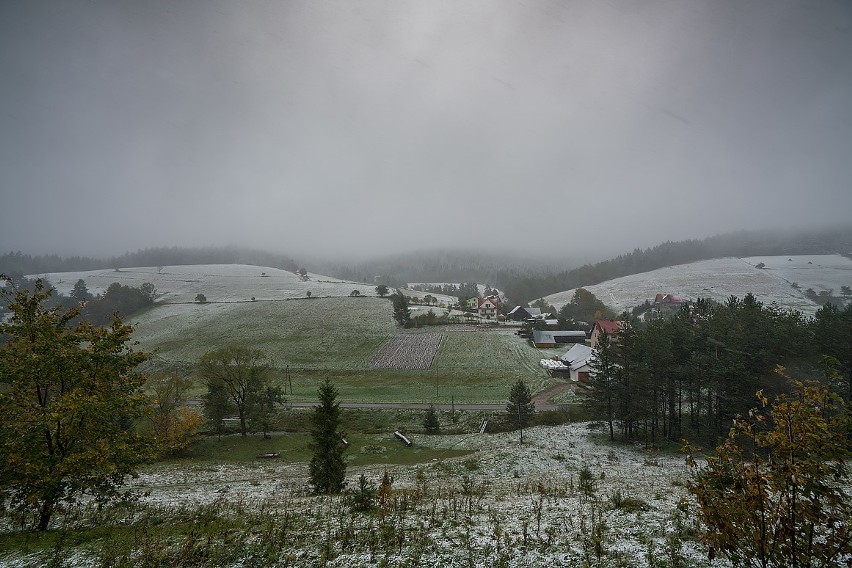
[[687, 374, 852, 567]]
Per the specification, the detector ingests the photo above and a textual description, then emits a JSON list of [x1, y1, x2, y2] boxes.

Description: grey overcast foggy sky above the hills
[[0, 0, 852, 258]]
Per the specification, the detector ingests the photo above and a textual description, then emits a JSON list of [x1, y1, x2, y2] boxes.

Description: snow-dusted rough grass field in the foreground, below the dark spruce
[[118, 423, 728, 566]]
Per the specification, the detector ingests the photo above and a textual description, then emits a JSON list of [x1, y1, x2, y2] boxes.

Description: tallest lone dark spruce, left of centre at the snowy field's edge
[[310, 379, 346, 494]]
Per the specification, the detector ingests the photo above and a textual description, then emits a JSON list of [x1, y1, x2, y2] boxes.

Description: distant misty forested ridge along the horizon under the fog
[[0, 227, 852, 304]]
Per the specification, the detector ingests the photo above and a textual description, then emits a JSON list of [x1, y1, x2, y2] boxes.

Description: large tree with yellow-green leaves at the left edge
[[0, 276, 148, 531]]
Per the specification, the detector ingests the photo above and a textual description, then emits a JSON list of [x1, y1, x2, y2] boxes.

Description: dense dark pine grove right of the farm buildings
[[587, 295, 852, 445]]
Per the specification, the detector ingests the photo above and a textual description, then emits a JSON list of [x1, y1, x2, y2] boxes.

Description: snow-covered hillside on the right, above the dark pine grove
[[544, 255, 852, 315]]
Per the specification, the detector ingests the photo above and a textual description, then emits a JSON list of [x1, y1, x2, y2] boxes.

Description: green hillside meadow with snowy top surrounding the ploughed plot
[[81, 266, 564, 403]]
